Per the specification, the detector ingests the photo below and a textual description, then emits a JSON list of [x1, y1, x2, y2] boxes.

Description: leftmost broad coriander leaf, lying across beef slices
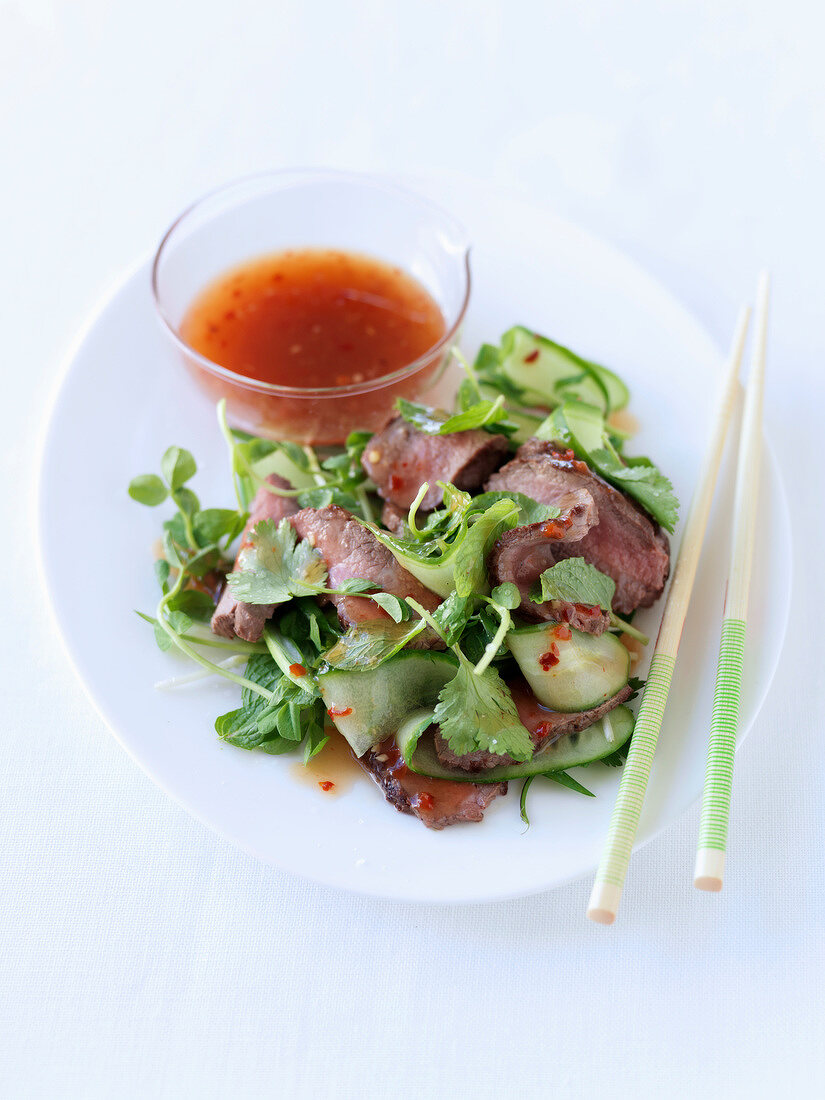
[[227, 519, 327, 604]]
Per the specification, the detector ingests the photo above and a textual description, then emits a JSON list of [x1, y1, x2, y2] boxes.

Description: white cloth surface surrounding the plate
[[0, 0, 825, 1098]]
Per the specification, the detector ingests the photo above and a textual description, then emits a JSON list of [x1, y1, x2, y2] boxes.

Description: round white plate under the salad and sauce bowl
[[40, 180, 791, 902]]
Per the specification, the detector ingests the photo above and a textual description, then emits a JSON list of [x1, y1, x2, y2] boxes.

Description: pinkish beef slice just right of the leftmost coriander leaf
[[289, 504, 441, 645]]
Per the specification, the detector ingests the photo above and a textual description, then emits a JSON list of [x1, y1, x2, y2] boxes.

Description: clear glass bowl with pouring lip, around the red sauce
[[152, 169, 470, 444]]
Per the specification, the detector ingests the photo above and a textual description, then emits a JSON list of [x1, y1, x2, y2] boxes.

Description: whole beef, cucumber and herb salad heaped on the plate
[[129, 327, 679, 829]]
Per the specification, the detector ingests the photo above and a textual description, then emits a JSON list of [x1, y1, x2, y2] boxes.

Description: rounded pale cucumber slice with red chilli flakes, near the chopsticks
[[506, 623, 630, 713]]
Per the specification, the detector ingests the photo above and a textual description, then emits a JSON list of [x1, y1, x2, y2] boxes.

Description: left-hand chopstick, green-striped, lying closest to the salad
[[587, 309, 750, 924]]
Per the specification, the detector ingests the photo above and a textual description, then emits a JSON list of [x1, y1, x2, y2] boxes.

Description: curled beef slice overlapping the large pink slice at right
[[487, 488, 611, 634]]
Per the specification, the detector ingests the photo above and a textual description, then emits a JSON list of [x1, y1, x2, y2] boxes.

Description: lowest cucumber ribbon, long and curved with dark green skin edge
[[396, 706, 634, 783]]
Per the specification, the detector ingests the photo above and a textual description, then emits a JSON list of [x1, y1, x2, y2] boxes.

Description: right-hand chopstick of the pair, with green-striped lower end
[[693, 273, 769, 890]]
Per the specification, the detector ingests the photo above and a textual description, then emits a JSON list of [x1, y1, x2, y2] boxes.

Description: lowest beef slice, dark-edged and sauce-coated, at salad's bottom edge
[[361, 738, 507, 828]]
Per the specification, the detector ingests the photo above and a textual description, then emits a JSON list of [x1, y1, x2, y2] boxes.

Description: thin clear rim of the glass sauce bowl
[[152, 168, 471, 397]]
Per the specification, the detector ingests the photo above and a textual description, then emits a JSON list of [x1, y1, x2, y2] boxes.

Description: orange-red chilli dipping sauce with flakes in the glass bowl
[[180, 249, 446, 443]]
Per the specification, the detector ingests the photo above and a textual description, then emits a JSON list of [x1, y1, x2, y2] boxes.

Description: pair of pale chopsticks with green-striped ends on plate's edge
[[587, 274, 769, 924]]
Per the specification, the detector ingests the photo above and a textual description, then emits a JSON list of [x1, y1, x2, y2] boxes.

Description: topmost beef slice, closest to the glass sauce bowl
[[361, 417, 508, 512]]
